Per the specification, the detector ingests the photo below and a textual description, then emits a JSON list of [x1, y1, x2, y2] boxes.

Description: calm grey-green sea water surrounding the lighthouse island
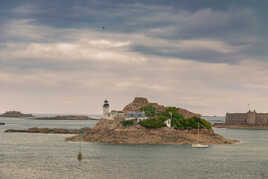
[[0, 117, 268, 179]]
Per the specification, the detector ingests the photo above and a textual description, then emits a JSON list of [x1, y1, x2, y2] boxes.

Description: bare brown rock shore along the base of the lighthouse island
[[66, 119, 239, 144]]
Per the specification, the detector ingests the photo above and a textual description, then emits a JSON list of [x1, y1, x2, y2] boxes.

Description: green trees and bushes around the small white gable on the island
[[140, 106, 211, 130]]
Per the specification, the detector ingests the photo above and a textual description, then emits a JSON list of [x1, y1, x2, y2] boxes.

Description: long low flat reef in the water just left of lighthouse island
[[5, 128, 90, 134]]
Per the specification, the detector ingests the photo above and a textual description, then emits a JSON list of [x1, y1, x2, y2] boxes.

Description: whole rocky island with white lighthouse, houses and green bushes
[[66, 97, 239, 144]]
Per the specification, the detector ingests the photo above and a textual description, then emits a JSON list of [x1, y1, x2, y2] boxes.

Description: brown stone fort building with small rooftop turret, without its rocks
[[225, 110, 268, 126]]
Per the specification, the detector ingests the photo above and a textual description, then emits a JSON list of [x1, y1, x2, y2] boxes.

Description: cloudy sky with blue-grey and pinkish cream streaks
[[0, 0, 268, 115]]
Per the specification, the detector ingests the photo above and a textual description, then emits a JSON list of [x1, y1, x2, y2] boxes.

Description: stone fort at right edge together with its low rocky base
[[213, 110, 268, 129]]
